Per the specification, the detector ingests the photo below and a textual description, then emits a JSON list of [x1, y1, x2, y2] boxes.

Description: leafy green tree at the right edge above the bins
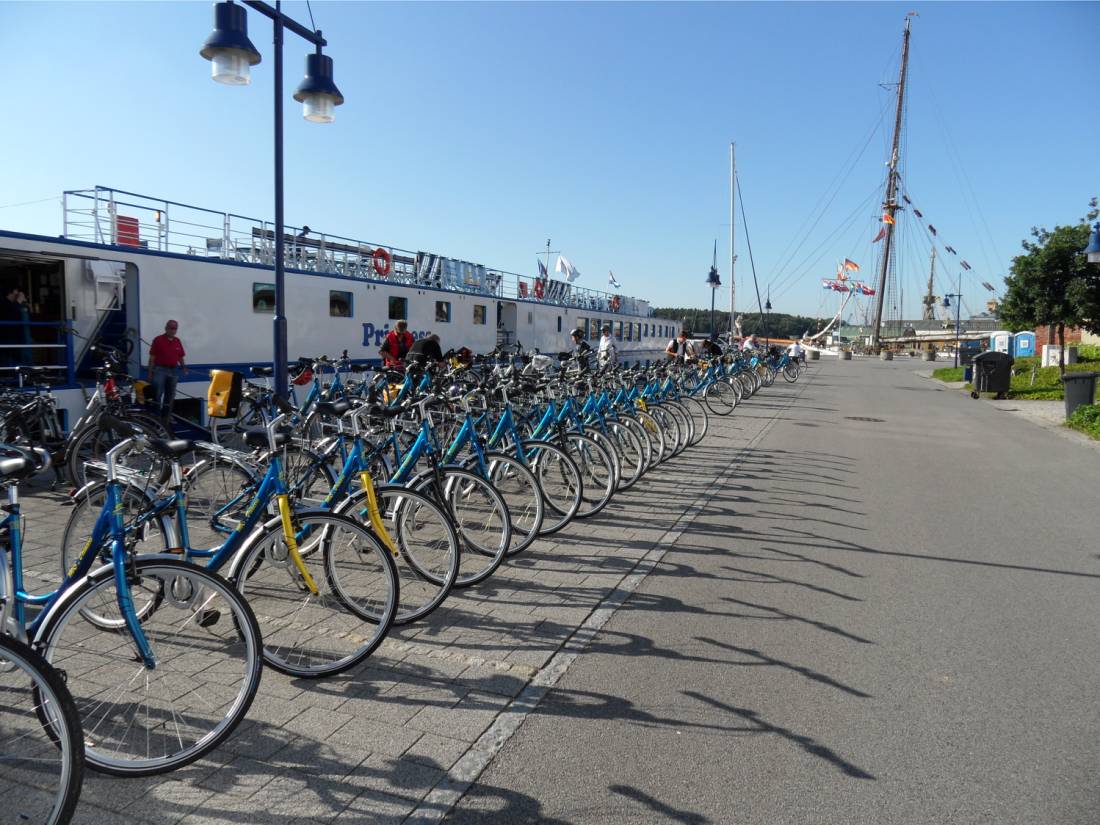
[[1000, 198, 1100, 374]]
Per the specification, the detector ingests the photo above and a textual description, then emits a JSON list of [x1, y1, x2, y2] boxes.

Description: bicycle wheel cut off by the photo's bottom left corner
[[0, 636, 84, 825]]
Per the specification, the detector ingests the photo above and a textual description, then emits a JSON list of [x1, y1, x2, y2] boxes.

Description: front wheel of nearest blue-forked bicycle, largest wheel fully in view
[[35, 557, 262, 777]]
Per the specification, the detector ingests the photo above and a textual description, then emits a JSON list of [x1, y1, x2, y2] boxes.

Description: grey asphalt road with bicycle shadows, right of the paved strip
[[447, 360, 1100, 825]]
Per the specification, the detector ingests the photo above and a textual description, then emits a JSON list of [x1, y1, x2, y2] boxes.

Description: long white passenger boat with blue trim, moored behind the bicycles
[[0, 187, 679, 429]]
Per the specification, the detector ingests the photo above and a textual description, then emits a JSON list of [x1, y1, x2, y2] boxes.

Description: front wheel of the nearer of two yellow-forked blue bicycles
[[231, 510, 399, 679]]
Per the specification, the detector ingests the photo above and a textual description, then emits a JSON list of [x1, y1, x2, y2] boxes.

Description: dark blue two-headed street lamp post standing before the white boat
[[199, 0, 343, 398]]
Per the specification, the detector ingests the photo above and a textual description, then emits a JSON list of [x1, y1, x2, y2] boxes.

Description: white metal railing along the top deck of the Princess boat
[[62, 186, 652, 317]]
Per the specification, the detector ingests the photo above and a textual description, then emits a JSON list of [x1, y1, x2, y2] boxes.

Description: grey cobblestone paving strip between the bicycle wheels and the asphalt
[[8, 378, 800, 825]]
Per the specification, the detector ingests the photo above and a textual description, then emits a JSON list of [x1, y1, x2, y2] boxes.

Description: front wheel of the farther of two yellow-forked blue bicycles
[[336, 485, 462, 625]]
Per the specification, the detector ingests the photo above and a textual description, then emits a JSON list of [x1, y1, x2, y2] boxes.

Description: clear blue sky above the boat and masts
[[0, 0, 1100, 317]]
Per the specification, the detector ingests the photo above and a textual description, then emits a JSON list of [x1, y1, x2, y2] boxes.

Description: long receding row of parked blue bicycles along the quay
[[0, 343, 792, 822]]
